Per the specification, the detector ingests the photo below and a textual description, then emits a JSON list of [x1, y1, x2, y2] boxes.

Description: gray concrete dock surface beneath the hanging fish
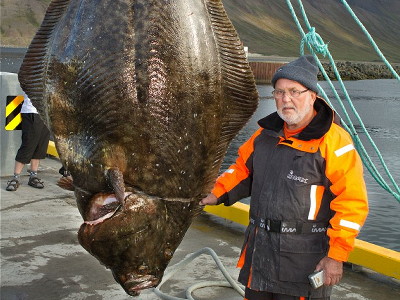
[[0, 158, 400, 300]]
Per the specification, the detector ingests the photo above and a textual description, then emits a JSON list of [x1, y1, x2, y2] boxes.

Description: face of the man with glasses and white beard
[[274, 78, 316, 129]]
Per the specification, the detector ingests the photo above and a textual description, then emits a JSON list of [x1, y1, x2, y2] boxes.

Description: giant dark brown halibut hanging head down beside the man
[[19, 0, 258, 295]]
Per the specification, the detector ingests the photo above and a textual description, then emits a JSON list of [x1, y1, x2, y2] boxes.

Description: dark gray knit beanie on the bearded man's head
[[271, 55, 318, 93]]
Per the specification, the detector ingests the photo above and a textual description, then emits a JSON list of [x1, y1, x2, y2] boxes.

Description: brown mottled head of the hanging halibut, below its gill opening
[[78, 193, 197, 296]]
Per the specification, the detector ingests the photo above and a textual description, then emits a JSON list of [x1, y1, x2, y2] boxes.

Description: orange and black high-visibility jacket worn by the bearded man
[[212, 97, 368, 297]]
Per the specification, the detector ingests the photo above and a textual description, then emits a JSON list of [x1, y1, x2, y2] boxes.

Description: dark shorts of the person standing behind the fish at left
[[15, 114, 50, 164]]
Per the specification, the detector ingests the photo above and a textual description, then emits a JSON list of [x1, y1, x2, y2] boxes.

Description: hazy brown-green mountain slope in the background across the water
[[0, 0, 400, 63]]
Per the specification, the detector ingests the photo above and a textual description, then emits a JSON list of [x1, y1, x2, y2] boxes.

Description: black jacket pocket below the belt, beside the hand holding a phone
[[279, 233, 327, 283]]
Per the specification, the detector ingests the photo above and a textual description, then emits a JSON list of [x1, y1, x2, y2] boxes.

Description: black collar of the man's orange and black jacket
[[258, 96, 335, 141]]
